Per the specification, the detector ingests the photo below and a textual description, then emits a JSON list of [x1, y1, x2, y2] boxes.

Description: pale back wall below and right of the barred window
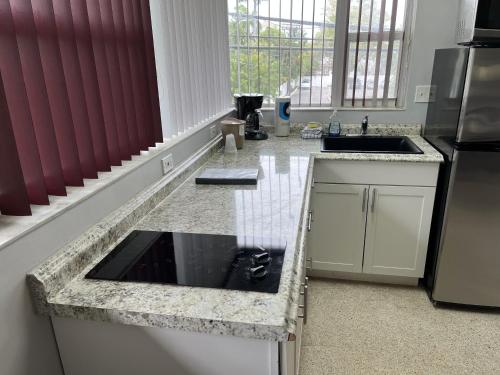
[[264, 0, 459, 124]]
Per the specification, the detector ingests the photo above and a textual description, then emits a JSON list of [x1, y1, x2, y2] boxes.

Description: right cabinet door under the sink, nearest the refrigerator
[[363, 186, 435, 277]]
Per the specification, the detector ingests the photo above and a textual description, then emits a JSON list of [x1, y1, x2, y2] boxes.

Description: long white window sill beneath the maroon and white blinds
[[0, 108, 233, 250]]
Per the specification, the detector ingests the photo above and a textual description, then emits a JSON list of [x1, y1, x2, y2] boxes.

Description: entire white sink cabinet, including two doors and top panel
[[308, 160, 439, 282]]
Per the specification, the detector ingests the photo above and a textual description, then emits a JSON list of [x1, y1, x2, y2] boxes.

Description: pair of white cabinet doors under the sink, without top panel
[[308, 178, 436, 279]]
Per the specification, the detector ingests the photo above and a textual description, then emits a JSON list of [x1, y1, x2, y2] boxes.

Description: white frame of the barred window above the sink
[[229, 0, 416, 111]]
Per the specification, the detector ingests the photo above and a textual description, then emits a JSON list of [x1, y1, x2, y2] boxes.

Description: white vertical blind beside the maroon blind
[[150, 0, 233, 138]]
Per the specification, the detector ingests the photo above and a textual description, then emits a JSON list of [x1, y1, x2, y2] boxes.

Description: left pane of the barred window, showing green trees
[[228, 0, 336, 106]]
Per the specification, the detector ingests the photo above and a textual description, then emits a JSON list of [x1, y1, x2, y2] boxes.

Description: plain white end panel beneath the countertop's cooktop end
[[52, 317, 282, 375]]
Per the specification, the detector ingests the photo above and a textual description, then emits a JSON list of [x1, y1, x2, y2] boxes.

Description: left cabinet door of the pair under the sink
[[309, 183, 368, 272]]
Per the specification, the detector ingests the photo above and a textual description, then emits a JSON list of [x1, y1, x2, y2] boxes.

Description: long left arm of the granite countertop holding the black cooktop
[[42, 139, 317, 341]]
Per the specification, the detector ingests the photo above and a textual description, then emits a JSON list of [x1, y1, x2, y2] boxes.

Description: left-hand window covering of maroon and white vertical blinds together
[[0, 0, 233, 215]]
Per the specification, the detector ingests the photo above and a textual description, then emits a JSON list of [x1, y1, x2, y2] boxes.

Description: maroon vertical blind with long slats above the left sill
[[0, 0, 163, 215]]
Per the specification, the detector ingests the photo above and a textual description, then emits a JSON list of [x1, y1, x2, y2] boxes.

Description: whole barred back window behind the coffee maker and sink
[[228, 0, 411, 108]]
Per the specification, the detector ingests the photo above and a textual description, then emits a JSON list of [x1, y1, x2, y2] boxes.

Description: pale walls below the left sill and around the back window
[[0, 0, 457, 375]]
